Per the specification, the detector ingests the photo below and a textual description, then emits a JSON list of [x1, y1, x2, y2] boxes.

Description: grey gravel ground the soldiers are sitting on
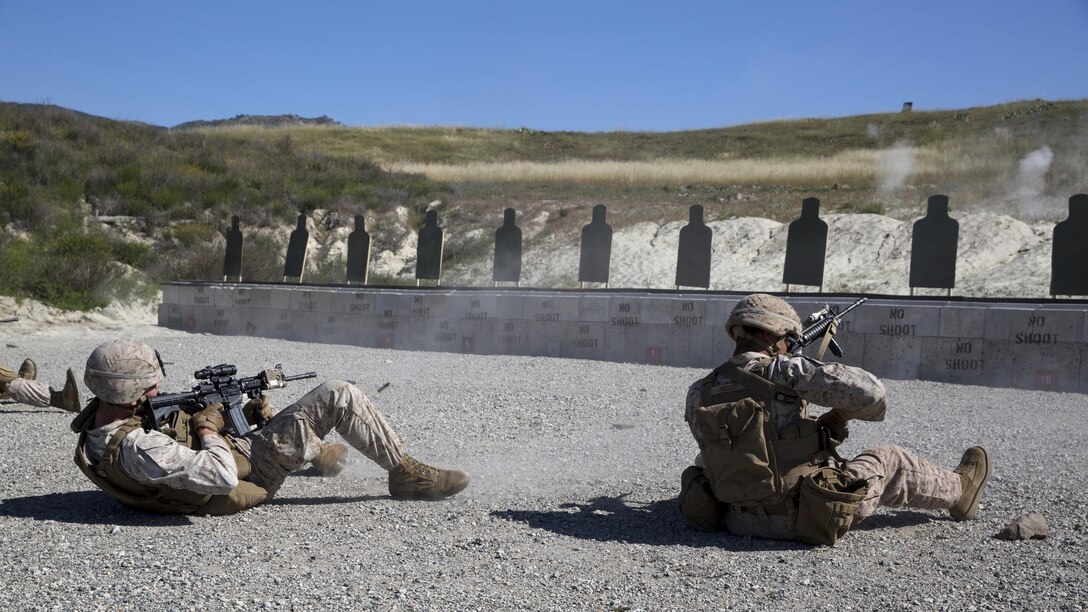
[[0, 327, 1088, 611]]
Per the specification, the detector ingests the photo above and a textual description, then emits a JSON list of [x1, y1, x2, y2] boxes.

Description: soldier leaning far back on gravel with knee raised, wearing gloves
[[72, 340, 469, 514]]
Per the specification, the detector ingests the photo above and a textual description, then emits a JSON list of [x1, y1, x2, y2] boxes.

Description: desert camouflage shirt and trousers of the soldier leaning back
[[85, 381, 404, 499]]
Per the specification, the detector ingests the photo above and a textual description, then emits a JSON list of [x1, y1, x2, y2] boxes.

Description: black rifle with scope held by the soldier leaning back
[[147, 364, 318, 437]]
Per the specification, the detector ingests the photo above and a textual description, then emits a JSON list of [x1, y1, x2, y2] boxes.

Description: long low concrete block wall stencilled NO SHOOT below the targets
[[159, 282, 1088, 393]]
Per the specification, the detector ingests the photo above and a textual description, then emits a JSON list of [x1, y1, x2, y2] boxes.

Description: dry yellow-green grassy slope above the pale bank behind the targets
[[198, 100, 1088, 220]]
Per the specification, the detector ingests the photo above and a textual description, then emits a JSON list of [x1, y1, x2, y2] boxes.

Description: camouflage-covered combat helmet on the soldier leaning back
[[83, 340, 165, 405]]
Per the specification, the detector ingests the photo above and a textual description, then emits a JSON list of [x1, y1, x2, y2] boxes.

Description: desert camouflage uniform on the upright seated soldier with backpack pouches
[[684, 353, 962, 525]]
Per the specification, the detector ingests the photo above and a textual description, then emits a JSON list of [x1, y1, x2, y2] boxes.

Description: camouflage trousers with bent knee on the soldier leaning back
[[239, 380, 404, 499]]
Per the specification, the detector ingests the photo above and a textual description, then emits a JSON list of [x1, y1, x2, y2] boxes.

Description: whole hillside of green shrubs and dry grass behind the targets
[[0, 100, 1088, 308]]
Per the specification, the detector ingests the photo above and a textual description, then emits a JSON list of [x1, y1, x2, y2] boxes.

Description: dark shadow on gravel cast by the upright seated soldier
[[491, 493, 812, 552]]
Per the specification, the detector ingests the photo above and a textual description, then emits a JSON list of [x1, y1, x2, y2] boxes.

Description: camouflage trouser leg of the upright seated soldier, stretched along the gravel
[[845, 444, 962, 521]]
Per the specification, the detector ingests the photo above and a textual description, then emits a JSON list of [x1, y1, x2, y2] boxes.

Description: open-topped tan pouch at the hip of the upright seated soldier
[[796, 467, 869, 546]]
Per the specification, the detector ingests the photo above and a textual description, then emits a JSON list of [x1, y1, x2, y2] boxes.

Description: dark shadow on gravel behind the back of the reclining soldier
[[0, 491, 191, 527]]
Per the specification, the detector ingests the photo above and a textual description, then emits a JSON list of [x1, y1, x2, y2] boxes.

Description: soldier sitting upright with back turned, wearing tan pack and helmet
[[680, 294, 990, 544]]
